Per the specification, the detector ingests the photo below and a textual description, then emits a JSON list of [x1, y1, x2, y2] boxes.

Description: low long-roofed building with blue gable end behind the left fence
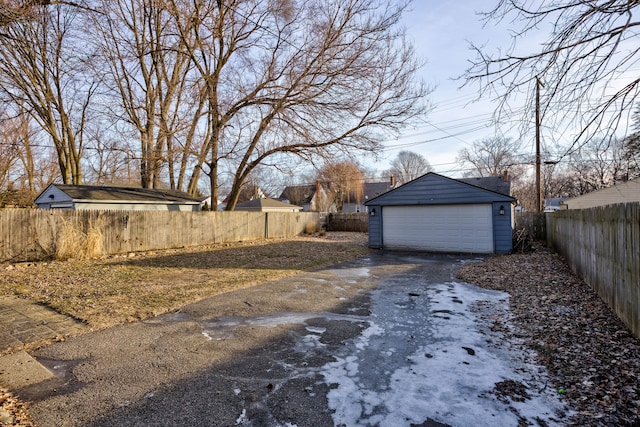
[[35, 184, 200, 211]]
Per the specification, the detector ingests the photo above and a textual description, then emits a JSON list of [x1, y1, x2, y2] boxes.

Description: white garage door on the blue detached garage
[[382, 204, 493, 253]]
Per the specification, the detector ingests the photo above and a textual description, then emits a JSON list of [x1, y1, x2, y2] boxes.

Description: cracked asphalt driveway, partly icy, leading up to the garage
[[17, 252, 569, 427]]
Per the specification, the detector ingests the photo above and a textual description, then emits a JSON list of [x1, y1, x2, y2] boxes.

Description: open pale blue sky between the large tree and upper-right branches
[[375, 0, 533, 177]]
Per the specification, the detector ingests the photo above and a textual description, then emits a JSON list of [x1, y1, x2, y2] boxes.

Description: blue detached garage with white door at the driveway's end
[[365, 172, 515, 253]]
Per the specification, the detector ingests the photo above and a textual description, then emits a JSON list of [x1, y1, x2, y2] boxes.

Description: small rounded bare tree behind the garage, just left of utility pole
[[457, 136, 522, 178]]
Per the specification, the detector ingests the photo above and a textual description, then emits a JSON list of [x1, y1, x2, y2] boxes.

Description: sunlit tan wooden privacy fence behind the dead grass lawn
[[0, 209, 319, 262]]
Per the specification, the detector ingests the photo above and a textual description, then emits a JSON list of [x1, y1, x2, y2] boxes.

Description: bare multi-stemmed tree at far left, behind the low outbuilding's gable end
[[0, 6, 98, 184]]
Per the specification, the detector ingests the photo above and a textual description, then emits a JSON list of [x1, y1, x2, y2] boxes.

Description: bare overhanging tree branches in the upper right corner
[[465, 0, 640, 158]]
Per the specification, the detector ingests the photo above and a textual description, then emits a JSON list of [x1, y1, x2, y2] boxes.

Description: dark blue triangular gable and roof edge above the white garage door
[[365, 172, 515, 206]]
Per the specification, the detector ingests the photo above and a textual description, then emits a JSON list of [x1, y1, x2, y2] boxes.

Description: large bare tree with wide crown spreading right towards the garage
[[171, 0, 427, 210]]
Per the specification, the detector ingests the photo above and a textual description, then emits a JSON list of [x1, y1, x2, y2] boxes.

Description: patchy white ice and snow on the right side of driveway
[[322, 282, 565, 427]]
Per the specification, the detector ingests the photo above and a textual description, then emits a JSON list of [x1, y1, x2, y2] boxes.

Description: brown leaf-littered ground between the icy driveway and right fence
[[0, 236, 640, 426]]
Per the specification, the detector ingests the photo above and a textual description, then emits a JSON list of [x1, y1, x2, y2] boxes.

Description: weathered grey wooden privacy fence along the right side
[[547, 203, 640, 337]]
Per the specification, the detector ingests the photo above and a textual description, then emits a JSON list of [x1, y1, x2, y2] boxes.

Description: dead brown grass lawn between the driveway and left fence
[[0, 233, 369, 329]]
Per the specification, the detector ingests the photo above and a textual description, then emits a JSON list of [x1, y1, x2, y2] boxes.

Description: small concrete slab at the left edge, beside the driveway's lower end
[[0, 351, 56, 390]]
